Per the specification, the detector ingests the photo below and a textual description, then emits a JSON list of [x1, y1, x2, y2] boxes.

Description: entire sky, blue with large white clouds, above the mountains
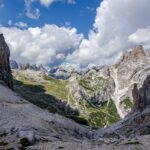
[[0, 0, 150, 67]]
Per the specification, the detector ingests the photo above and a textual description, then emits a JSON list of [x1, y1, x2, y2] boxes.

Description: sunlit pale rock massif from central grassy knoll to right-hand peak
[[65, 45, 150, 118]]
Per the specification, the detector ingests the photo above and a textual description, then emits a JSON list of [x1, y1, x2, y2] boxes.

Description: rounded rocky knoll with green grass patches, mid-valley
[[68, 67, 115, 106]]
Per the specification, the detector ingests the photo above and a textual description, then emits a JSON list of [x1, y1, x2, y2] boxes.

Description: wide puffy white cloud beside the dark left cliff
[[0, 25, 83, 65]]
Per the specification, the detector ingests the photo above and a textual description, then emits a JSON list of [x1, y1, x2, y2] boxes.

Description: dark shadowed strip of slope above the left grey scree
[[14, 79, 88, 125]]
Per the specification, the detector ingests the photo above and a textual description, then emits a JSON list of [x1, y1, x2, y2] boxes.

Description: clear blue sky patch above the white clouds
[[0, 0, 100, 37]]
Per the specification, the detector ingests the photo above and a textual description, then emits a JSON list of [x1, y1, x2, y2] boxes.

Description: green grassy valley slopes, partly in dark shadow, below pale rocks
[[14, 71, 120, 127]]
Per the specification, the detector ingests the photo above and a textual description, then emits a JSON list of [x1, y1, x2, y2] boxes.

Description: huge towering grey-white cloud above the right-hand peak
[[68, 0, 150, 65]]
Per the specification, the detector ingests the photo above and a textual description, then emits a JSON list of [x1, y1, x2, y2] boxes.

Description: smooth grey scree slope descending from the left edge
[[0, 85, 92, 149]]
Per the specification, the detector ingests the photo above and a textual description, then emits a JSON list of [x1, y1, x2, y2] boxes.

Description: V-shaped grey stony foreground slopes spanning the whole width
[[0, 81, 150, 150]]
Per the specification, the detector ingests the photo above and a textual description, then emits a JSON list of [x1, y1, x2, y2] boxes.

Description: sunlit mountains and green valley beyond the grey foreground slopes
[[10, 45, 150, 127]]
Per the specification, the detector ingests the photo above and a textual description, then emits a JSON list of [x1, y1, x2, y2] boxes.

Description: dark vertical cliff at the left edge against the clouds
[[0, 34, 13, 89]]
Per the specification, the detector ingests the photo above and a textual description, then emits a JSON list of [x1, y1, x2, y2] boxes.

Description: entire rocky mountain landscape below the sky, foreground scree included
[[0, 35, 150, 150]]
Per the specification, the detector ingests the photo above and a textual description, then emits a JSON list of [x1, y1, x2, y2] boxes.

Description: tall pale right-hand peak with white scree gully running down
[[110, 45, 150, 118]]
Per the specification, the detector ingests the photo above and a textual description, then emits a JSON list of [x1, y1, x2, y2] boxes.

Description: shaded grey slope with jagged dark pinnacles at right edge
[[96, 75, 150, 139]]
